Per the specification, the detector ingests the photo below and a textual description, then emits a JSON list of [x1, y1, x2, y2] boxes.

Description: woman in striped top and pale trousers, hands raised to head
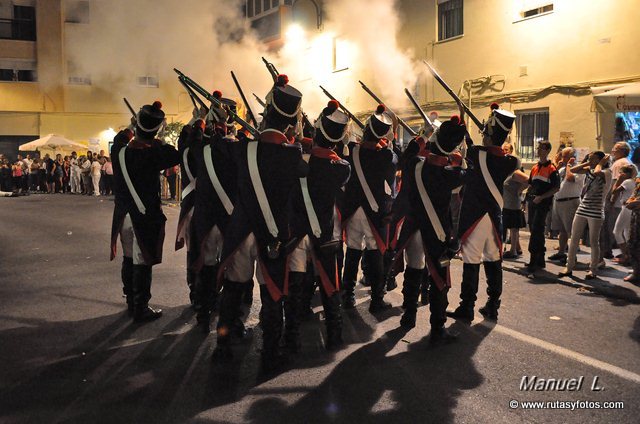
[[558, 151, 611, 279]]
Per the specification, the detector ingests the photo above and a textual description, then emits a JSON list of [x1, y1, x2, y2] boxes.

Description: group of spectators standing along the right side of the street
[[503, 141, 640, 284]]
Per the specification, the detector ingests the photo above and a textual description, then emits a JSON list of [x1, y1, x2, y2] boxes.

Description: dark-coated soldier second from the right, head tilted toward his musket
[[398, 116, 466, 342]]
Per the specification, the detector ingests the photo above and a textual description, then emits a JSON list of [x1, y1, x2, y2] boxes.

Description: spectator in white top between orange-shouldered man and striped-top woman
[[549, 147, 584, 262]]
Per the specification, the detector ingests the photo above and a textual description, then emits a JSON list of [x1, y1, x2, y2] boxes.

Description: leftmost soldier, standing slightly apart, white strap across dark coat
[[111, 101, 180, 322]]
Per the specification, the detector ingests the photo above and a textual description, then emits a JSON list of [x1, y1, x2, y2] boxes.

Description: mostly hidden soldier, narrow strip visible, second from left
[[175, 117, 197, 305]]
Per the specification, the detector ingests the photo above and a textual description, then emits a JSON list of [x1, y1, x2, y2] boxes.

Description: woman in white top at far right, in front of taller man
[[611, 165, 638, 265]]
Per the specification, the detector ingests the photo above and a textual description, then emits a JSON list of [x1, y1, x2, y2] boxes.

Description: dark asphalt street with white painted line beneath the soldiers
[[0, 194, 640, 423]]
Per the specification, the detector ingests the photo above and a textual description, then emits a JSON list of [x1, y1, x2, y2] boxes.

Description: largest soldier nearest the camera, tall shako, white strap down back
[[215, 75, 308, 370]]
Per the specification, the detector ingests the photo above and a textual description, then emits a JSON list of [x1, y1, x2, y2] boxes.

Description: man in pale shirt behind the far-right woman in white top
[[600, 141, 631, 265]]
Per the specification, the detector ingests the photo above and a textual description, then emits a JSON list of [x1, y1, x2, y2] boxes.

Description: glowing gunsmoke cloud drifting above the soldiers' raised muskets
[[66, 0, 419, 124]]
